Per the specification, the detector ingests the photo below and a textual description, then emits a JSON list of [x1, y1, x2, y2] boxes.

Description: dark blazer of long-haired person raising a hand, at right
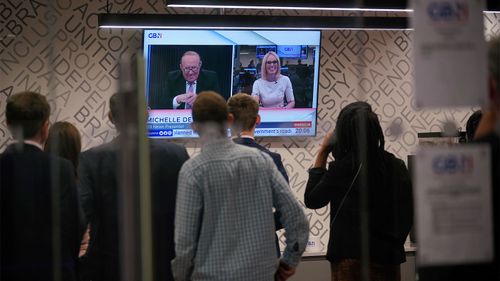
[[304, 152, 413, 264]]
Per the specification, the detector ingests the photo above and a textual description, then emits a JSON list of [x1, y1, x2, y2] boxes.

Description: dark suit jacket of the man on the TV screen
[[149, 69, 220, 109]]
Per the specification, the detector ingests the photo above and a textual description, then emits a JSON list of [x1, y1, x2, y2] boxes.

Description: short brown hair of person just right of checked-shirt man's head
[[227, 93, 259, 132]]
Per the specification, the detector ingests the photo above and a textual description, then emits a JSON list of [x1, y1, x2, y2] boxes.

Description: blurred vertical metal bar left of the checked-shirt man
[[118, 53, 153, 281]]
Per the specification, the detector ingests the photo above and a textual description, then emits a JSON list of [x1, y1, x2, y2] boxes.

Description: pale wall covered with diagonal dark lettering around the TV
[[0, 0, 500, 254]]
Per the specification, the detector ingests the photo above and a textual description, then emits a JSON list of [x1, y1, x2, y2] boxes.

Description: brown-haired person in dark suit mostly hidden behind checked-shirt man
[[227, 93, 288, 257]]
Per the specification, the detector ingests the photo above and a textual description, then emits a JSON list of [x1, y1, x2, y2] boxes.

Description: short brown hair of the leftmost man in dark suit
[[5, 92, 50, 139]]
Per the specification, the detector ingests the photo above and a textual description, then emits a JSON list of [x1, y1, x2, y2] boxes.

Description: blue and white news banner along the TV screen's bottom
[[148, 108, 316, 138]]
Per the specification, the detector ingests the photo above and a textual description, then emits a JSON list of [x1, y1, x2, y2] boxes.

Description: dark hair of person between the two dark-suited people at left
[[44, 121, 82, 175]]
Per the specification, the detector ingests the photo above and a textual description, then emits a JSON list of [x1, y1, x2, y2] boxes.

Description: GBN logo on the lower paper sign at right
[[432, 154, 474, 175]]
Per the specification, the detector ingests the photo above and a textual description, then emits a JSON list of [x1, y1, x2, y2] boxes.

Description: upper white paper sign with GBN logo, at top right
[[413, 0, 488, 107]]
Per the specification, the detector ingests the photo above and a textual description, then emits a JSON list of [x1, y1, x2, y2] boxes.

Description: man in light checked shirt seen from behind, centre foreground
[[172, 92, 309, 281]]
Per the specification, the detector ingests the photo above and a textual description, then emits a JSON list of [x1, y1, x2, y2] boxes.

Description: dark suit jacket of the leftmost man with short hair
[[0, 143, 81, 281]]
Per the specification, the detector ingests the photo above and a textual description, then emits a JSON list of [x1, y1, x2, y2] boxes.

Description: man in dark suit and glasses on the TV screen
[[149, 51, 220, 109]]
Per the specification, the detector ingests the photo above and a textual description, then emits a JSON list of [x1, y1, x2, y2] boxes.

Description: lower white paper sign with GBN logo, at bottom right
[[414, 145, 493, 266]]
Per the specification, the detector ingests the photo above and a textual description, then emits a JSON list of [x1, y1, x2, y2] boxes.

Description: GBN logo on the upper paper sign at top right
[[427, 0, 469, 27]]
